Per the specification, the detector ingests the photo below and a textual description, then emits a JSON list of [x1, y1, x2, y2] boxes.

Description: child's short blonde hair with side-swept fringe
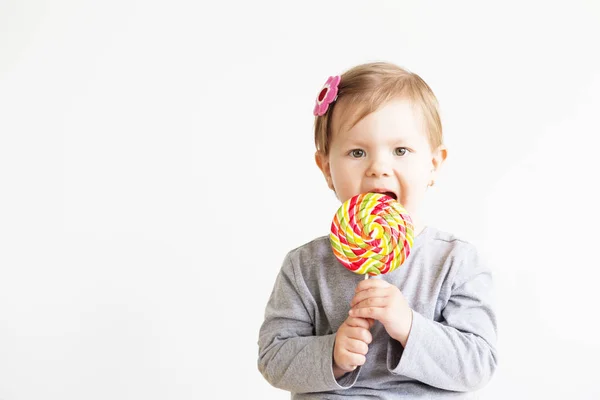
[[315, 62, 443, 155]]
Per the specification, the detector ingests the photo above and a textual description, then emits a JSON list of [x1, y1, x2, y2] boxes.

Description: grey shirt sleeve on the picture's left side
[[258, 254, 358, 393]]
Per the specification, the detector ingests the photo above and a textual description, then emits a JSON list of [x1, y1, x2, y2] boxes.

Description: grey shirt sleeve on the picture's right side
[[387, 245, 497, 392]]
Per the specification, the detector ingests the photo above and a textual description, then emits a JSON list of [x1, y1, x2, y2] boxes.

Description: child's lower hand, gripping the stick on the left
[[333, 317, 373, 379]]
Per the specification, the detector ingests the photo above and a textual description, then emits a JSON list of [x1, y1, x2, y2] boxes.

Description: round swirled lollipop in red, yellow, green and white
[[329, 193, 414, 279]]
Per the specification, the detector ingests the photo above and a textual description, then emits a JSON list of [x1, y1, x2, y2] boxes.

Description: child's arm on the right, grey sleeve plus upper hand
[[351, 246, 496, 391]]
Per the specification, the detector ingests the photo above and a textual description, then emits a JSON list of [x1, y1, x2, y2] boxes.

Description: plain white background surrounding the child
[[0, 0, 600, 400]]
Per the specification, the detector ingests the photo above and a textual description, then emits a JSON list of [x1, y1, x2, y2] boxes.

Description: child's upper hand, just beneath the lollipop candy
[[350, 279, 412, 346]]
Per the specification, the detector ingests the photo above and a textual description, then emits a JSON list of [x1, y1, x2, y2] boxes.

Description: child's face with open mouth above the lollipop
[[317, 99, 446, 228]]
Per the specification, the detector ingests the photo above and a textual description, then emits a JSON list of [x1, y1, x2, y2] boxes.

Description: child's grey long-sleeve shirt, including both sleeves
[[258, 227, 496, 399]]
